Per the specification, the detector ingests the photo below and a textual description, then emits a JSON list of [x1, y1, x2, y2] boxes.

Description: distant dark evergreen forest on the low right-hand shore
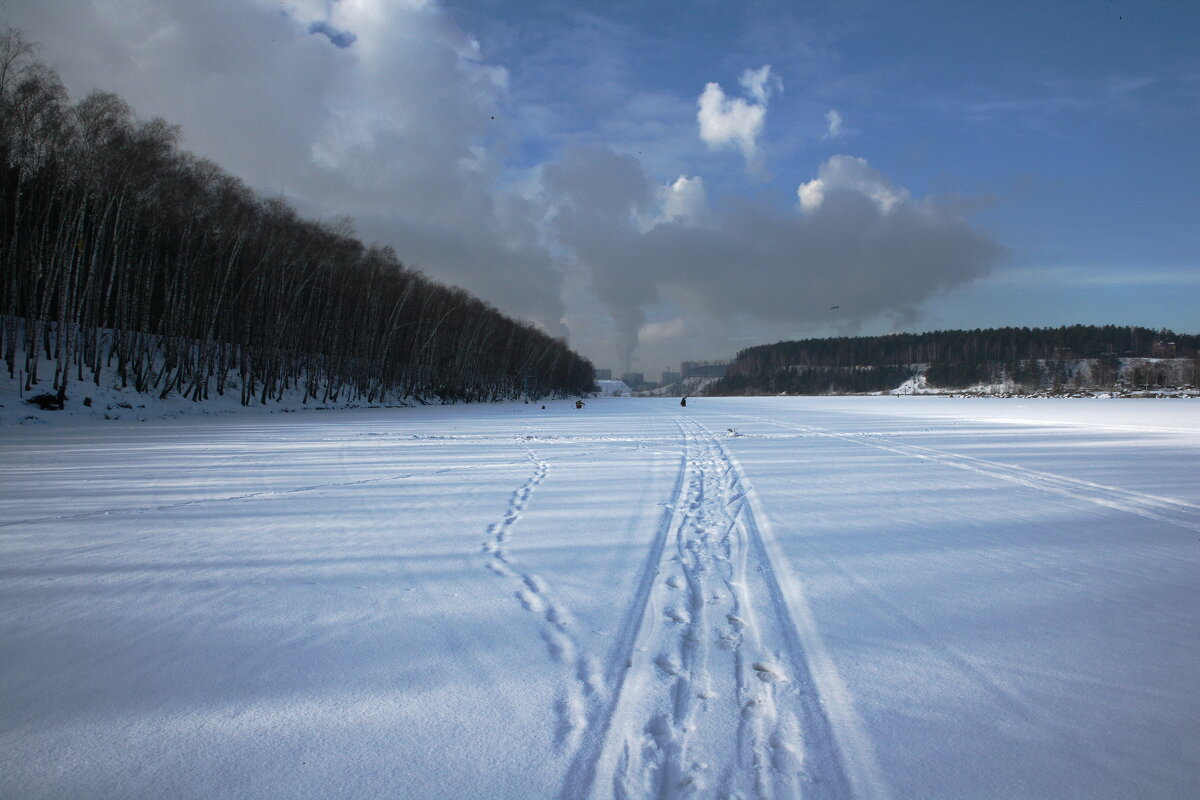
[[707, 325, 1200, 395]]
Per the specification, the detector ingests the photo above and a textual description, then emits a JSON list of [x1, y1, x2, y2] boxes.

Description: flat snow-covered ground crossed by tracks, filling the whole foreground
[[0, 397, 1200, 799]]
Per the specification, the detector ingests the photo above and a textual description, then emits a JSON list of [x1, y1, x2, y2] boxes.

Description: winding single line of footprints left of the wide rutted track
[[482, 438, 602, 751]]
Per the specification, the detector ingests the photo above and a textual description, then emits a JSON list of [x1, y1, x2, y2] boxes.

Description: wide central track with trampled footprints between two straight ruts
[[563, 417, 873, 800]]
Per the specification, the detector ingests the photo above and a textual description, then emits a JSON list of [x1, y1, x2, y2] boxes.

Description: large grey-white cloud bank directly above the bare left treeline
[[6, 0, 566, 335]]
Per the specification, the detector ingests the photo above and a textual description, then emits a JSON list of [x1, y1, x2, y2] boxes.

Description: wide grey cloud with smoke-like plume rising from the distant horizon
[[544, 146, 1001, 368]]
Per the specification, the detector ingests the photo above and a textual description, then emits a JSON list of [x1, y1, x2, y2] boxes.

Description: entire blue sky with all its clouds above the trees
[[0, 0, 1200, 375]]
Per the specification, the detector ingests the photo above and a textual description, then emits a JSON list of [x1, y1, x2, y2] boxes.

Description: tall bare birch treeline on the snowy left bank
[[0, 30, 593, 403]]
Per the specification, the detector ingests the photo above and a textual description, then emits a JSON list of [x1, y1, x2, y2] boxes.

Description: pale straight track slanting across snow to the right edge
[[738, 414, 1200, 533]]
